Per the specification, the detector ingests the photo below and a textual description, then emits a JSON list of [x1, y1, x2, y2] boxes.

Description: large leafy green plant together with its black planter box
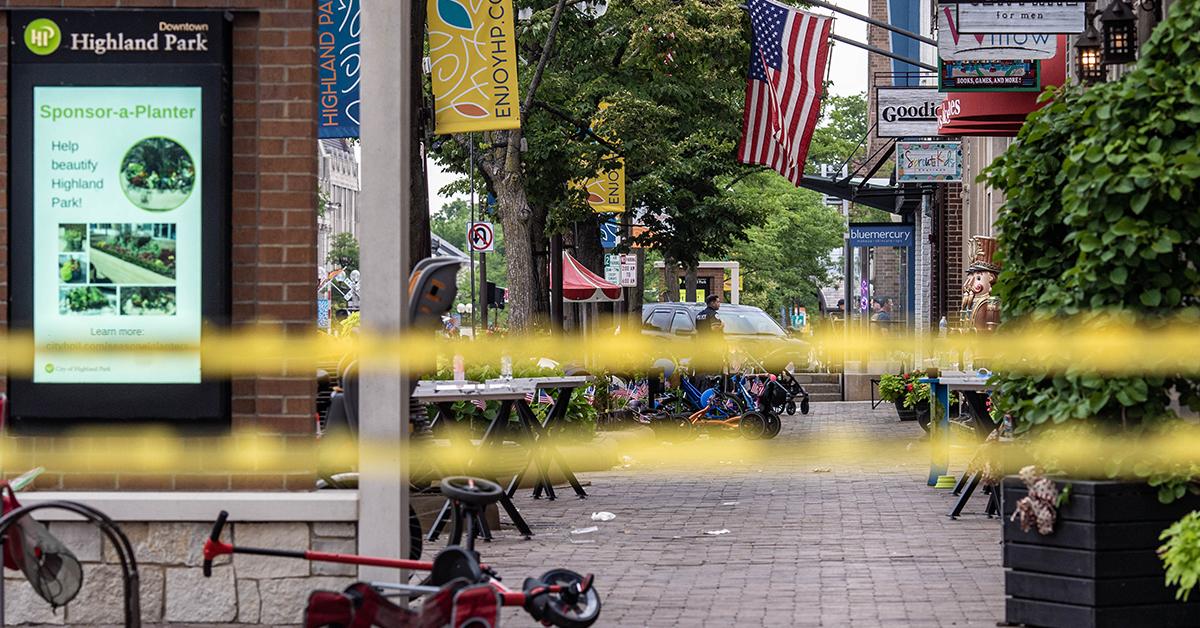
[[985, 7, 1200, 627]]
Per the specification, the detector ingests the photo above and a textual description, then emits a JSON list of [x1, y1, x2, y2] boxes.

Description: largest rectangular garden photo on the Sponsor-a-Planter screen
[[88, 222, 175, 285]]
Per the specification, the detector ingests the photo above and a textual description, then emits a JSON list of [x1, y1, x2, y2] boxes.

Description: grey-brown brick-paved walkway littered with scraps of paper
[[478, 402, 1004, 627]]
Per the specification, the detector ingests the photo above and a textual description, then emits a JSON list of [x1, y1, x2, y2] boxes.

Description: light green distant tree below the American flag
[[733, 172, 844, 313]]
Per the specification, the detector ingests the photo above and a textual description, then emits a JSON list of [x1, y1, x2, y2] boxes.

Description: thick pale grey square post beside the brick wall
[[358, 0, 416, 581]]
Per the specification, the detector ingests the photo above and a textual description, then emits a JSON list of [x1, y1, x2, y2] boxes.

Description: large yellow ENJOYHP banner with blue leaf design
[[426, 0, 521, 134]]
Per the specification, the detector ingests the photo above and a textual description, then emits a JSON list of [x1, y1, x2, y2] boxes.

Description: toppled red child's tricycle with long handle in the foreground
[[203, 477, 600, 628]]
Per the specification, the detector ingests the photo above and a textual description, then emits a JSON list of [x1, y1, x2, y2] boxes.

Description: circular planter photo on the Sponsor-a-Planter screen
[[120, 137, 196, 211]]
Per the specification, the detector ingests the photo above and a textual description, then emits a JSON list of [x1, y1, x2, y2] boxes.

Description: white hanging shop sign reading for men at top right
[[956, 2, 1084, 34]]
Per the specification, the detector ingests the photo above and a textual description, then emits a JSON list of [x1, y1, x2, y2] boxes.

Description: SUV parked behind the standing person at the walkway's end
[[642, 303, 809, 372]]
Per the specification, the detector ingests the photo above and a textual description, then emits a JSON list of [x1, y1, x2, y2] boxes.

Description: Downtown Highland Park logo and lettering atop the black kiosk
[[25, 18, 209, 56]]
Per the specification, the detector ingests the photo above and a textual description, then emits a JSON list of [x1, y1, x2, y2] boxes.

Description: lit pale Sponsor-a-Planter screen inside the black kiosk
[[34, 86, 204, 384]]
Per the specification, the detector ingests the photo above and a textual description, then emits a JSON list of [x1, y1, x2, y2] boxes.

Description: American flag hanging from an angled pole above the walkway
[[738, 0, 833, 185]]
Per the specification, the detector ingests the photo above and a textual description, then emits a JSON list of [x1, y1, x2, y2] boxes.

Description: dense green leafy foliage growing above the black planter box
[[986, 0, 1200, 429]]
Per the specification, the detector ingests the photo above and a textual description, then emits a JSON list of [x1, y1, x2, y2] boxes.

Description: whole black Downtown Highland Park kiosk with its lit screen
[[10, 11, 229, 424]]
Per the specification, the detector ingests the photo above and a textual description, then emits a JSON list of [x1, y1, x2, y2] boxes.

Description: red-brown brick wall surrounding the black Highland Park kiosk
[[0, 0, 317, 490]]
